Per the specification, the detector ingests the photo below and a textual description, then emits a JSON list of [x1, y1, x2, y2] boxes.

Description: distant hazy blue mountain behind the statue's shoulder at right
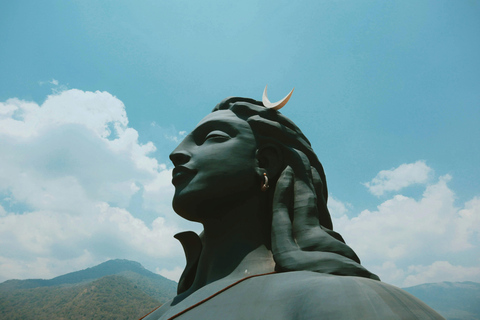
[[403, 281, 480, 320]]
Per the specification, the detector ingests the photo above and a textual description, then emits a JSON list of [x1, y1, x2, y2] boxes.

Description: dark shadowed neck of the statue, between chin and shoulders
[[189, 197, 275, 292]]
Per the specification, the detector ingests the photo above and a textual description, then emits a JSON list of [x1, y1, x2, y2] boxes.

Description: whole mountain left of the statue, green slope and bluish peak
[[0, 260, 177, 319]]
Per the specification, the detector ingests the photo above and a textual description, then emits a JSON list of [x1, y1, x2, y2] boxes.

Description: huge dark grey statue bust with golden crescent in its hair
[[144, 88, 443, 320]]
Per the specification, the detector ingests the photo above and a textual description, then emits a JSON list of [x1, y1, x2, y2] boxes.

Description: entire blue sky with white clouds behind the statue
[[0, 1, 480, 286]]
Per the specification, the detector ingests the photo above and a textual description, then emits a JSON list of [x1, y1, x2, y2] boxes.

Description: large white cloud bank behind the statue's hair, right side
[[332, 162, 480, 286]]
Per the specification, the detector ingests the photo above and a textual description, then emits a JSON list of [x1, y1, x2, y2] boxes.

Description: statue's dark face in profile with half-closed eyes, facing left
[[170, 110, 260, 222]]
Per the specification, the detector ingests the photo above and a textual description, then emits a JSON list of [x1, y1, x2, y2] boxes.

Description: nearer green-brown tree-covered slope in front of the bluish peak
[[0, 275, 160, 319]]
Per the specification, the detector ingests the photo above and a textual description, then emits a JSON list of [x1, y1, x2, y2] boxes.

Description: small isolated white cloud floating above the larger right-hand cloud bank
[[364, 161, 432, 196]]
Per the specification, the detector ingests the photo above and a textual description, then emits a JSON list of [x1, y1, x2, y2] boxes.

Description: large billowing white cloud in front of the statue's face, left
[[0, 89, 195, 281]]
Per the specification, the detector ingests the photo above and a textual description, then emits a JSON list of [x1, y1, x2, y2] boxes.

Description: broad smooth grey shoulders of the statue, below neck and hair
[[138, 271, 443, 320]]
